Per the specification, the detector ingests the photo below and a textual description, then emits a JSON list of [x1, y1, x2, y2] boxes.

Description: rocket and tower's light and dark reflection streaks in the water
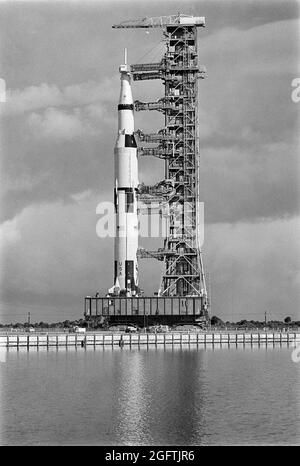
[[110, 347, 206, 445]]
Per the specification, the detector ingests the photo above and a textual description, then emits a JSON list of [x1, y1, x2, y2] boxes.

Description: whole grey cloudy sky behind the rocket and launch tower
[[0, 0, 300, 322]]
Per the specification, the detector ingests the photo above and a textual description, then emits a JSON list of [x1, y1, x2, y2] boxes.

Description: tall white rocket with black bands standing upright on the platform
[[109, 49, 139, 296]]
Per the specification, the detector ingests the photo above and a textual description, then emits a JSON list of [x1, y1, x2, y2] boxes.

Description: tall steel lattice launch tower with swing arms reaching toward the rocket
[[86, 14, 209, 328]]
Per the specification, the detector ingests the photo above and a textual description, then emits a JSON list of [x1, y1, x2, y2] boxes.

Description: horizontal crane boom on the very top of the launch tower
[[112, 13, 205, 29]]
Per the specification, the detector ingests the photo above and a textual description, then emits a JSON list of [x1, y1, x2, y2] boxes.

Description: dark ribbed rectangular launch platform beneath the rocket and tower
[[84, 296, 205, 326]]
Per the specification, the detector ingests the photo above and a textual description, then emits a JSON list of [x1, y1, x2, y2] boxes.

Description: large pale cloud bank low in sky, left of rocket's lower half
[[0, 193, 113, 307]]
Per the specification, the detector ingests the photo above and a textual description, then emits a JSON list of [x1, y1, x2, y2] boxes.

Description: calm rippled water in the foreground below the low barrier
[[0, 346, 300, 445]]
